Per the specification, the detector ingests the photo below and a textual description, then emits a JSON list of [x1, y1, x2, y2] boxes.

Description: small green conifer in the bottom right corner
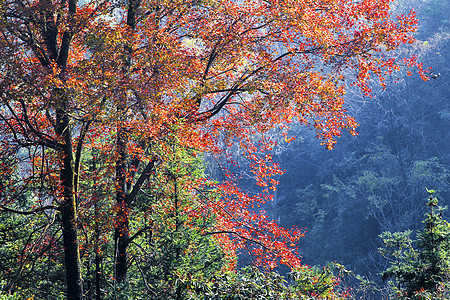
[[379, 190, 450, 299]]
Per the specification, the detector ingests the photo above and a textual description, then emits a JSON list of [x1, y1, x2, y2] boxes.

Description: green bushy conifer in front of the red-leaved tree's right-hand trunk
[[104, 136, 227, 299]]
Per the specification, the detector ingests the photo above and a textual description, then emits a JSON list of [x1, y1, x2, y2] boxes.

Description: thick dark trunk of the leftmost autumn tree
[[41, 0, 83, 300]]
